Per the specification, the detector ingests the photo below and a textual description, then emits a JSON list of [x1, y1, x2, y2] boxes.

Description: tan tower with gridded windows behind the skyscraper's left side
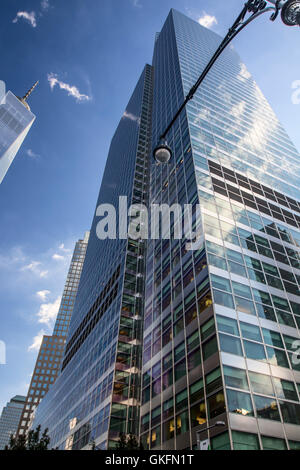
[[18, 232, 89, 435]]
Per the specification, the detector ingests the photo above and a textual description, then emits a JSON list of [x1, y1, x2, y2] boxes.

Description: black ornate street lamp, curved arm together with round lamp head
[[153, 0, 300, 163]]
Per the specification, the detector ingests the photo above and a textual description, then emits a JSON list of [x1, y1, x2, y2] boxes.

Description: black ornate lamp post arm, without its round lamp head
[[160, 0, 280, 142]]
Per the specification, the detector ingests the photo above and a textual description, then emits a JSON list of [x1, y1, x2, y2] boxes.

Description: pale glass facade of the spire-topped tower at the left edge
[[0, 91, 35, 184]]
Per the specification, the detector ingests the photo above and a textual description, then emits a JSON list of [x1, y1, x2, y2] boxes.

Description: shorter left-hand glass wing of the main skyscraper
[[33, 65, 152, 450]]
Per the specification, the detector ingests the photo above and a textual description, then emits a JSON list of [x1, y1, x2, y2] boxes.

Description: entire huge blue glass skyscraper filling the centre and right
[[35, 10, 300, 450]]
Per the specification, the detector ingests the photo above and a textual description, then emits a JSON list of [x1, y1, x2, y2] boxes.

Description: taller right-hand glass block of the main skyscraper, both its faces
[[141, 10, 300, 450]]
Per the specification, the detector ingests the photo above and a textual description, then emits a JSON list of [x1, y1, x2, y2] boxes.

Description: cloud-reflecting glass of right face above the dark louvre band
[[184, 26, 300, 198]]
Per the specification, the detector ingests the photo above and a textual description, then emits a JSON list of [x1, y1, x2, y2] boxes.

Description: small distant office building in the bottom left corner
[[0, 395, 26, 450]]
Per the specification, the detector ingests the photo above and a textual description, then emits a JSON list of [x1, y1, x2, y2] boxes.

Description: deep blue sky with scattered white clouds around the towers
[[0, 0, 300, 412]]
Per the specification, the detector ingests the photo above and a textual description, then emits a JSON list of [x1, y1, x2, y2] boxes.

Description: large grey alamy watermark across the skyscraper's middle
[[96, 196, 203, 250]]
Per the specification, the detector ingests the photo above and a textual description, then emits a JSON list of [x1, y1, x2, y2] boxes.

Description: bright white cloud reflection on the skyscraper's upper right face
[[214, 64, 299, 194]]
